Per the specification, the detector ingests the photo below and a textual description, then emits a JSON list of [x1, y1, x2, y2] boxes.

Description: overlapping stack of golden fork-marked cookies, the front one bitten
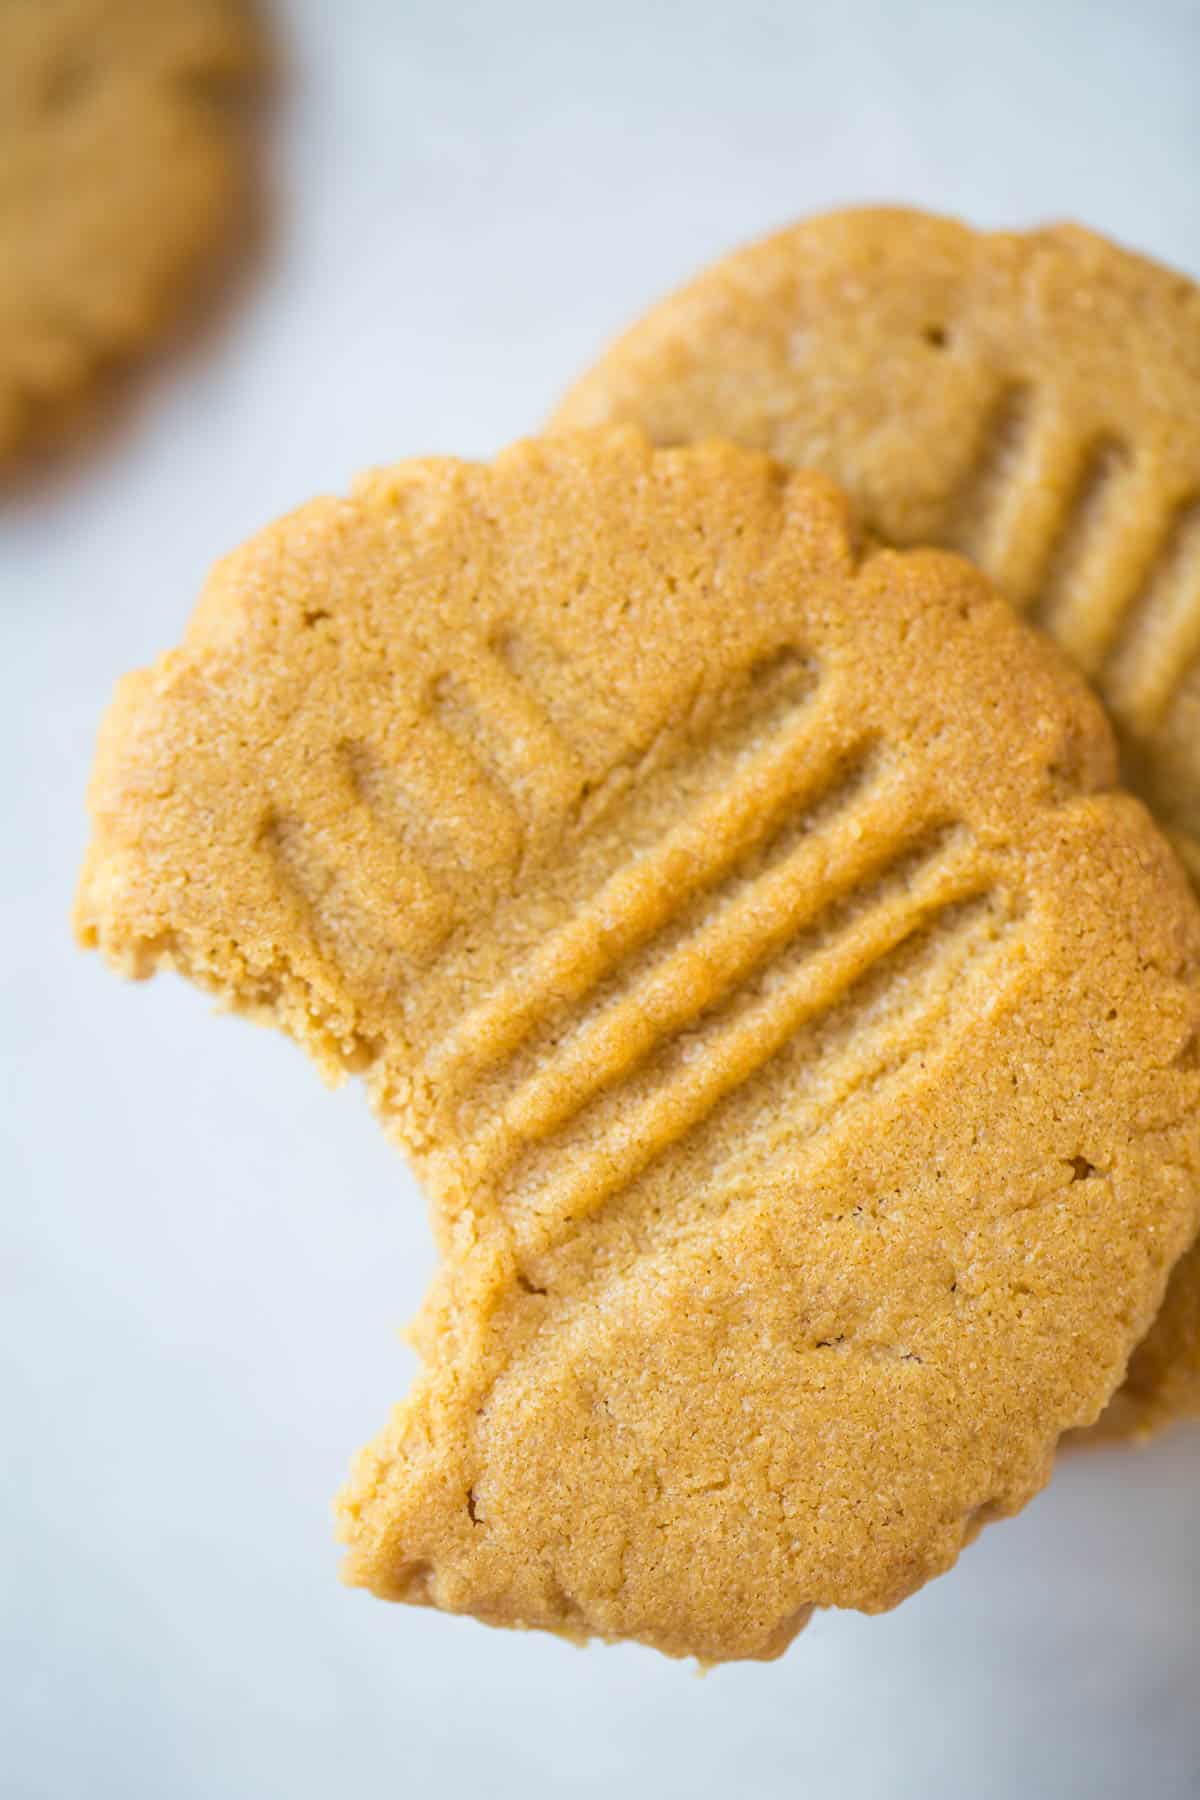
[[77, 214, 1200, 1661]]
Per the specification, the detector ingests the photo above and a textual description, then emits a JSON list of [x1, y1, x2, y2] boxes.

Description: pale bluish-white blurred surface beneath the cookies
[[0, 0, 1200, 1800]]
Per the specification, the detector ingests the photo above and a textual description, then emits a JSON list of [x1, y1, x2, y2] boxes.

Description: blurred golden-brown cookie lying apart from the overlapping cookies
[[0, 0, 259, 463]]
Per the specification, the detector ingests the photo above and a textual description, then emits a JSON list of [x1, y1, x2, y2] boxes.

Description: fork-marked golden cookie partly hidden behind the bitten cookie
[[554, 211, 1200, 1418]]
